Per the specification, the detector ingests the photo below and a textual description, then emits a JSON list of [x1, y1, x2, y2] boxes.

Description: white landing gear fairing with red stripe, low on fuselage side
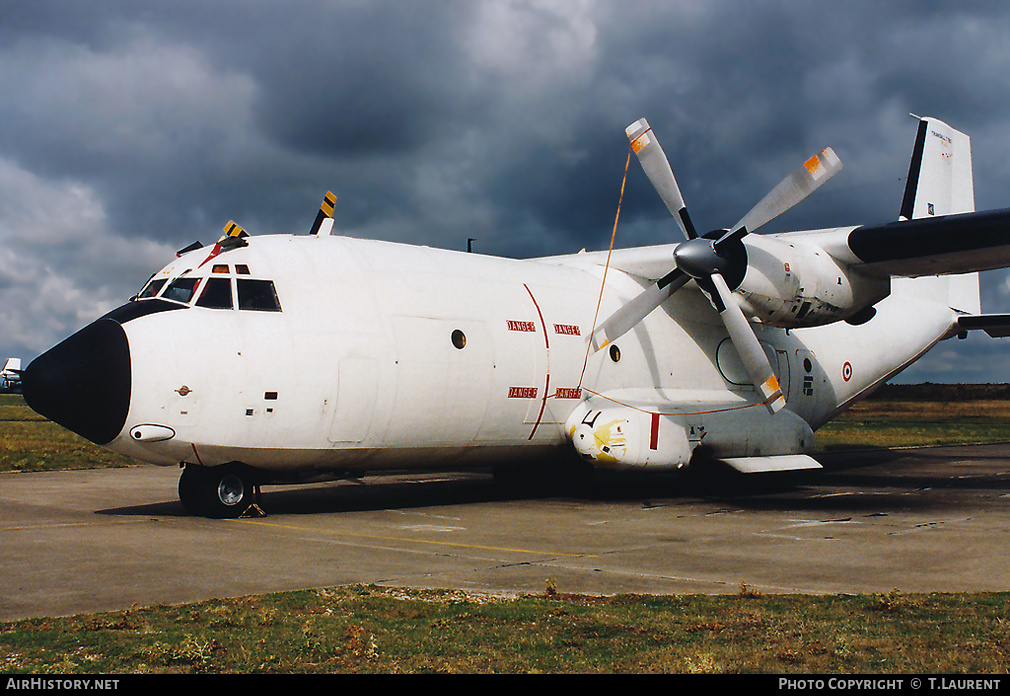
[[567, 390, 814, 470]]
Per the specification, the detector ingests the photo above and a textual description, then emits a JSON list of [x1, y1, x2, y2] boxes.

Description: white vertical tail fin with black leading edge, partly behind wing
[[900, 114, 982, 314]]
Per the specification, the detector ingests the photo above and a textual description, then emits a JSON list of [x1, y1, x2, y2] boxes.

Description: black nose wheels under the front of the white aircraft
[[179, 464, 256, 518]]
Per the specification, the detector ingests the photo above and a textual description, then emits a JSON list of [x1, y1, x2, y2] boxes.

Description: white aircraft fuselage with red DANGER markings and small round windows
[[107, 230, 954, 473]]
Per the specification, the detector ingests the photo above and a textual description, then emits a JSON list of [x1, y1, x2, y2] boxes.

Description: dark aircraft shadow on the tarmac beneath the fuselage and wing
[[98, 450, 1010, 517]]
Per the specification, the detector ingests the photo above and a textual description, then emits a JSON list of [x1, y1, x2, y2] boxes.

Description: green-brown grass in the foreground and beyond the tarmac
[[0, 387, 1010, 674]]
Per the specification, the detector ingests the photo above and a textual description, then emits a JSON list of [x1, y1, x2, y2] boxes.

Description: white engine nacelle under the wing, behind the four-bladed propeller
[[736, 234, 891, 328]]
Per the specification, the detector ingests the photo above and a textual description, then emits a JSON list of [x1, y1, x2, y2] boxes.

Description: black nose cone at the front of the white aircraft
[[21, 319, 131, 444]]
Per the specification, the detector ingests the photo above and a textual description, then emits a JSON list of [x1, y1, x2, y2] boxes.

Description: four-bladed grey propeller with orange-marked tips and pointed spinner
[[592, 118, 841, 413]]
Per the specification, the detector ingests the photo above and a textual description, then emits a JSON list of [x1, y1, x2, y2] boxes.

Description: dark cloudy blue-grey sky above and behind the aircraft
[[0, 0, 1010, 382]]
